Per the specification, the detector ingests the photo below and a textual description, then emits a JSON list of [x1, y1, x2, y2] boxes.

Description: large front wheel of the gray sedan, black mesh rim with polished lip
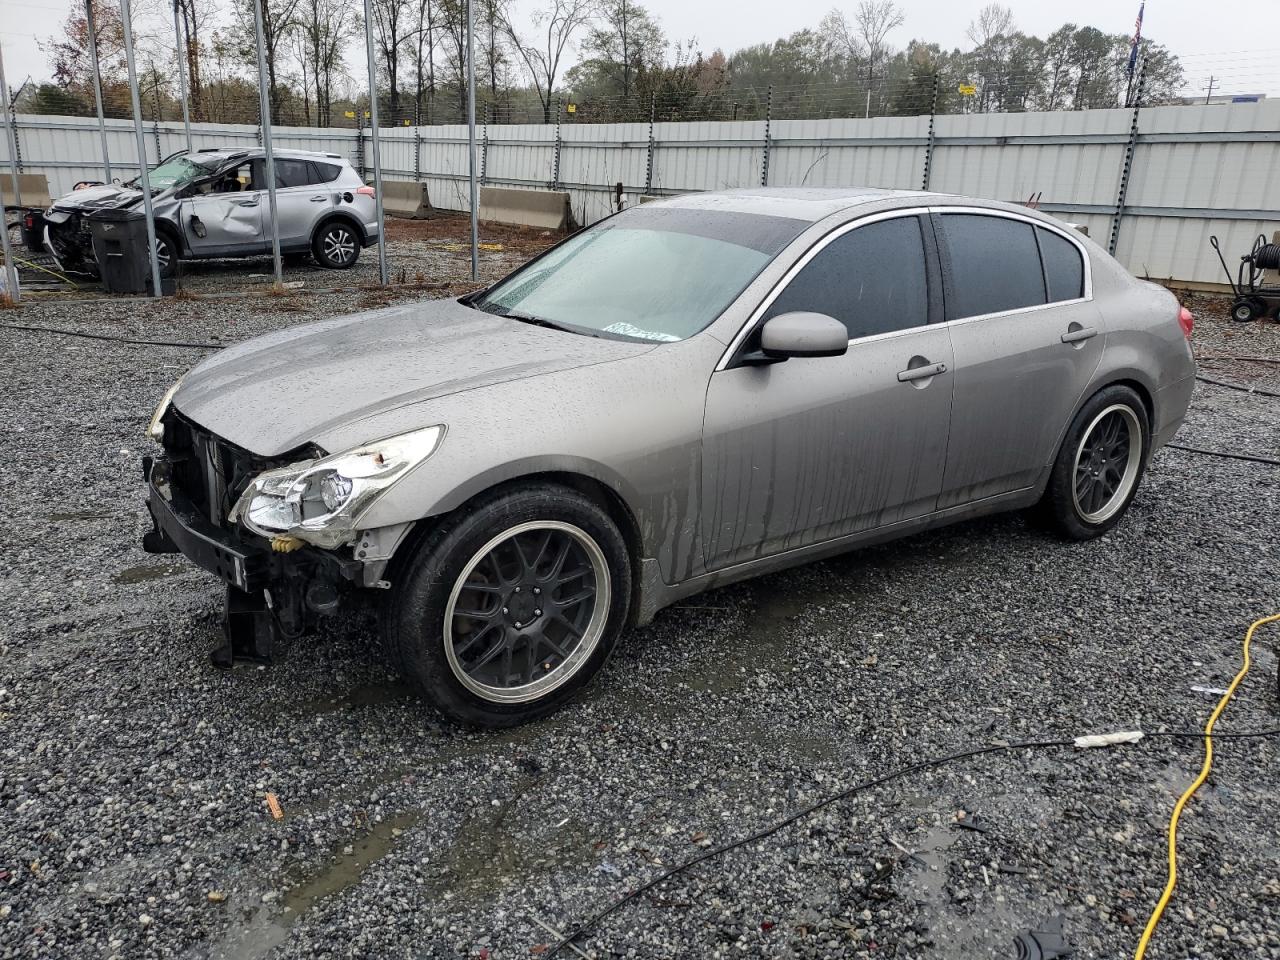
[[383, 484, 631, 728]]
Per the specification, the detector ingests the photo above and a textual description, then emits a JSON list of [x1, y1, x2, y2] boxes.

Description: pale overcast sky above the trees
[[0, 0, 1280, 96]]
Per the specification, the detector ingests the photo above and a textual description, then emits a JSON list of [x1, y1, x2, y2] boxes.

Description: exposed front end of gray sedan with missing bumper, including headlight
[[143, 401, 443, 666]]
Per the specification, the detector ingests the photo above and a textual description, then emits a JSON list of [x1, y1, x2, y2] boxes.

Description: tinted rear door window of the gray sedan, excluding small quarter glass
[[938, 214, 1046, 320]]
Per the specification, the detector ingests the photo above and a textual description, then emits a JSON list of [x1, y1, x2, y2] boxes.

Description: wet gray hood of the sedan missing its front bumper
[[173, 300, 654, 457]]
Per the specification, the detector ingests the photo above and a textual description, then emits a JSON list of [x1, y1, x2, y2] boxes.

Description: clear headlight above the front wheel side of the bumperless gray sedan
[[227, 425, 444, 549]]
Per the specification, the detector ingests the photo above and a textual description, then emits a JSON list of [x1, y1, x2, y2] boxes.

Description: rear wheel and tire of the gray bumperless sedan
[[1039, 384, 1151, 540]]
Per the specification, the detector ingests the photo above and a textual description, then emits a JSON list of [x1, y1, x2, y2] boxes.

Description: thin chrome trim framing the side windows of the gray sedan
[[714, 206, 1093, 372]]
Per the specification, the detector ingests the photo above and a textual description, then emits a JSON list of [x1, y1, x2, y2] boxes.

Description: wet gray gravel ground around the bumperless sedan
[[0, 272, 1280, 960]]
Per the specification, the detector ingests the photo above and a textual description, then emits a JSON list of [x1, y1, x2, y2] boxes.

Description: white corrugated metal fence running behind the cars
[[10, 101, 1280, 283]]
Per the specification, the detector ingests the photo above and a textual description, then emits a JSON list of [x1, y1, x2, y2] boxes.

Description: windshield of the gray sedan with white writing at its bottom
[[472, 206, 809, 342]]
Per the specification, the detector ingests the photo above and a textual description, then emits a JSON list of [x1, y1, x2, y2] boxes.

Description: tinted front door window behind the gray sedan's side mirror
[[764, 216, 929, 340]]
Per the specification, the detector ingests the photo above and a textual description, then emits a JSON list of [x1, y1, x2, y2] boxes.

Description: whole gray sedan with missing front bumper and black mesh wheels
[[148, 188, 1194, 726]]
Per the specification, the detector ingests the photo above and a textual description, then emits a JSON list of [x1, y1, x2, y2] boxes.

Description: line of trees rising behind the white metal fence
[[18, 0, 1184, 127]]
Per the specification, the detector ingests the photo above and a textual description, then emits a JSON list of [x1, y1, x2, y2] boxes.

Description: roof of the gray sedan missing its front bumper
[[662, 187, 1024, 223]]
